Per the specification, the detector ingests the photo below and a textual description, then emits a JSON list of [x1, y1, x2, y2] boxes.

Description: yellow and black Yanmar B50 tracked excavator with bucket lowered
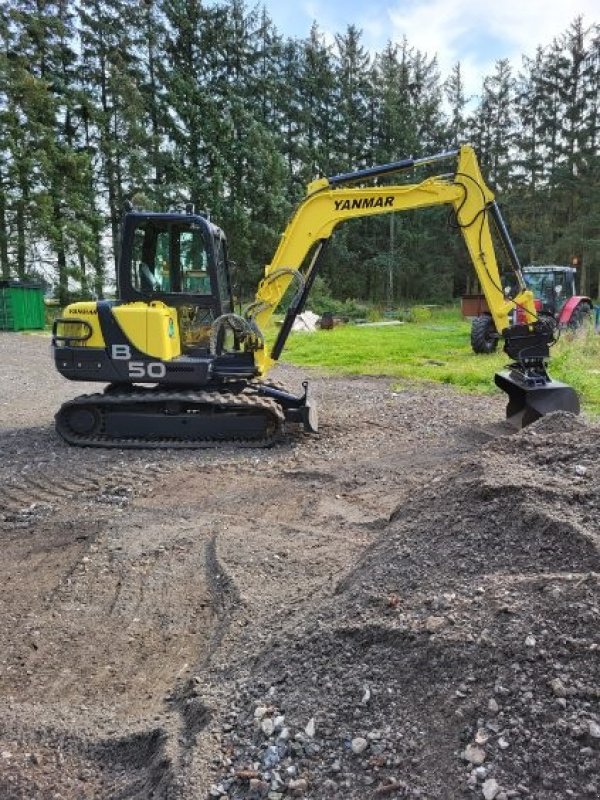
[[53, 146, 579, 448]]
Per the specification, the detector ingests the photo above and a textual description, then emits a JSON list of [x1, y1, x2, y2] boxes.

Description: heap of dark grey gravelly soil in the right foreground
[[212, 414, 600, 800]]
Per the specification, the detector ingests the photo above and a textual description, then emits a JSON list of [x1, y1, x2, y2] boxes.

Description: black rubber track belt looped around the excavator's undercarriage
[[55, 391, 285, 449]]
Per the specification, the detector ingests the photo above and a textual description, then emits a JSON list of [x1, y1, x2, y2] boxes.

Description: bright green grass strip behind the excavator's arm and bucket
[[283, 309, 600, 415]]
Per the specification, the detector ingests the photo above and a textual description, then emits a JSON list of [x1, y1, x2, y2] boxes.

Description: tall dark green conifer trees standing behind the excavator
[[0, 0, 600, 305]]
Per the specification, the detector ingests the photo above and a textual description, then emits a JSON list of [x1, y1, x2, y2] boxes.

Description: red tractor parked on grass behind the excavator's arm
[[471, 266, 594, 353]]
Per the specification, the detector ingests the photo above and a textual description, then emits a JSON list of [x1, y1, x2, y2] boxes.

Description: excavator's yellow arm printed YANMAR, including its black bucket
[[245, 146, 579, 424]]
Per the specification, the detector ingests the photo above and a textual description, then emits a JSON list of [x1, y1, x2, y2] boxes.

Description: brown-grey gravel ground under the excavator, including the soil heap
[[0, 334, 600, 800]]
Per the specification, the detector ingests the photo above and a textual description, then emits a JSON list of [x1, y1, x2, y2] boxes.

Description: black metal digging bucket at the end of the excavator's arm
[[494, 370, 579, 428]]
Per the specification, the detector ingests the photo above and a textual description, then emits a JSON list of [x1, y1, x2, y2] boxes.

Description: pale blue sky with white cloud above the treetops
[[263, 0, 600, 100]]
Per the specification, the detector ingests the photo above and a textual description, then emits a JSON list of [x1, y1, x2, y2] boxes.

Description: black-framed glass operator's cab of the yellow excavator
[[118, 211, 233, 352]]
